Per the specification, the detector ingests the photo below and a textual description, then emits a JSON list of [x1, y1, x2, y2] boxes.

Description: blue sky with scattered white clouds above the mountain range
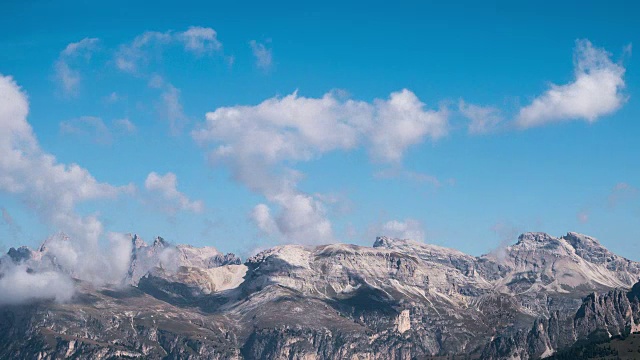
[[0, 1, 640, 260]]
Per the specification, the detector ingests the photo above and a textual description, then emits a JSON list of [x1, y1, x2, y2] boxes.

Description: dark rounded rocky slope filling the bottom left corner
[[0, 289, 238, 359]]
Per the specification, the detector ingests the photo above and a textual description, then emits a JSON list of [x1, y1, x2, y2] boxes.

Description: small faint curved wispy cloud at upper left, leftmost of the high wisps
[[54, 38, 99, 96]]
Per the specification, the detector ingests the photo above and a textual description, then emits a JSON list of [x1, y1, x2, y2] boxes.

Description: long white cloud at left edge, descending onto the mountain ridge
[[0, 76, 133, 298]]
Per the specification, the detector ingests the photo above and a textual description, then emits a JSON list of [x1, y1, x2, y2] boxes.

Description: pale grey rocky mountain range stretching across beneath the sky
[[0, 233, 640, 359]]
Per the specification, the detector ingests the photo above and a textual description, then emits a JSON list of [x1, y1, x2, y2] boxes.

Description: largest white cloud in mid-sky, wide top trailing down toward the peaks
[[192, 90, 447, 243]]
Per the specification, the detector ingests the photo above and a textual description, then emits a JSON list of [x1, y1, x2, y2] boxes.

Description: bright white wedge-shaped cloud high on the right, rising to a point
[[516, 40, 626, 128]]
